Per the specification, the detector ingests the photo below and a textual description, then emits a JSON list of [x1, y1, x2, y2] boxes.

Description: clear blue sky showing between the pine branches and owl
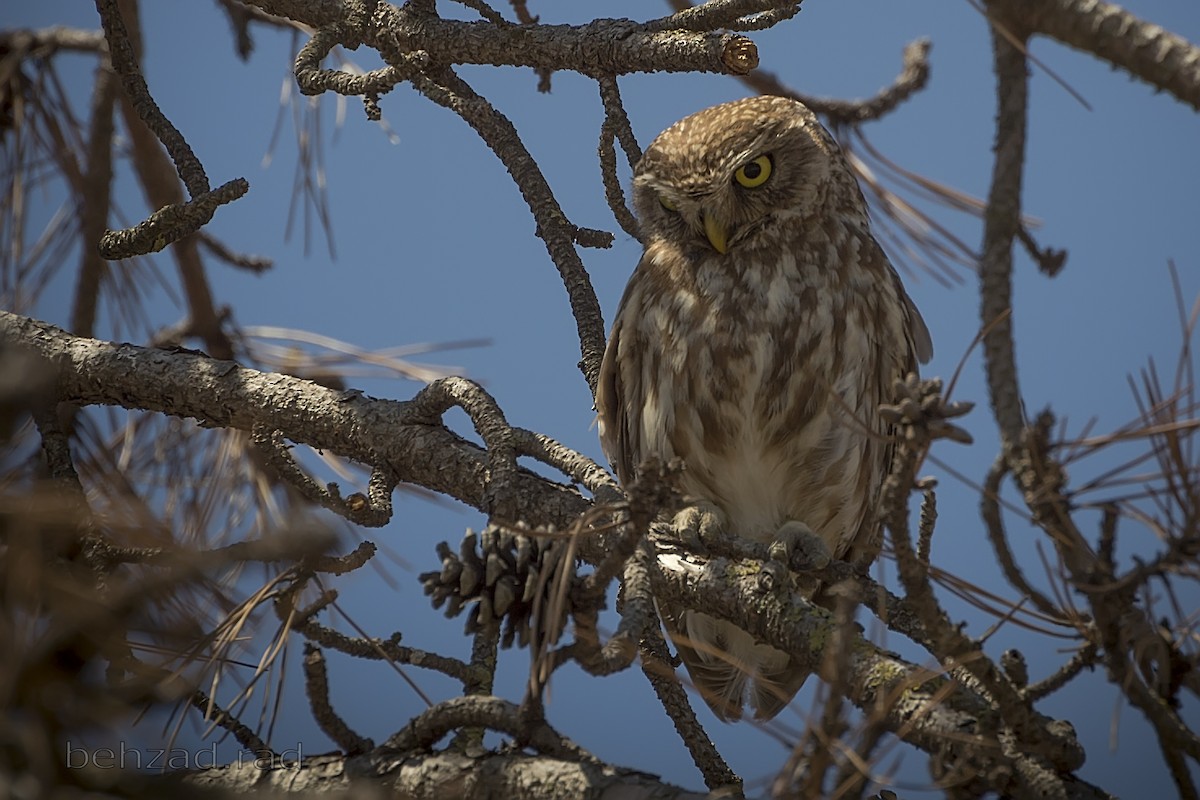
[[11, 0, 1200, 798]]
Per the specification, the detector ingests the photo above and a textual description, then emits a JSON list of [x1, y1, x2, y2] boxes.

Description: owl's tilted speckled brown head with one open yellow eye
[[634, 97, 865, 254]]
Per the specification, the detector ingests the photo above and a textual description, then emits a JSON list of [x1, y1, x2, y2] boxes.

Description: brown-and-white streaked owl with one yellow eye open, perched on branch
[[596, 97, 932, 721]]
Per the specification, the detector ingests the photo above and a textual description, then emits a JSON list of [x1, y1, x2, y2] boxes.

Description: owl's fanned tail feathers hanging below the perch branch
[[667, 612, 809, 722]]
